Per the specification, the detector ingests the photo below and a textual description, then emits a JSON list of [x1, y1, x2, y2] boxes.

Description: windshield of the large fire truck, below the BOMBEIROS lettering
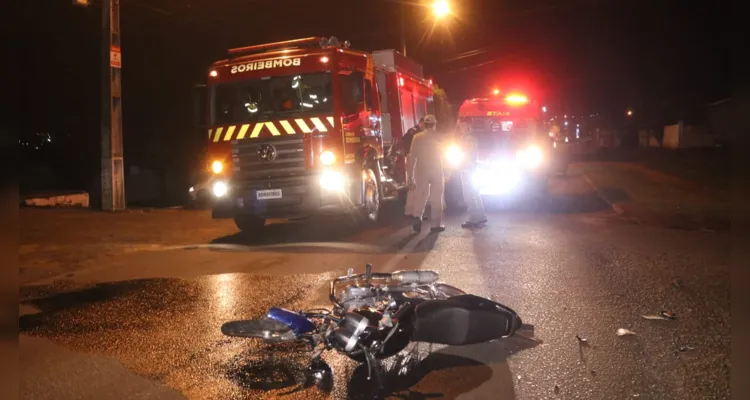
[[211, 73, 333, 125]]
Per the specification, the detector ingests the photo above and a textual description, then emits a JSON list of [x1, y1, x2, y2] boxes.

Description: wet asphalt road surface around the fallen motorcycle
[[19, 176, 730, 399]]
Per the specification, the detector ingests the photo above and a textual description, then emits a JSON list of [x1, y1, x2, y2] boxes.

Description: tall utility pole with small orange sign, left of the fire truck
[[101, 0, 125, 211]]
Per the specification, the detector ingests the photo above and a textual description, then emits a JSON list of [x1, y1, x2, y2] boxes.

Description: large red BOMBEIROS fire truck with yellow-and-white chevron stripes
[[207, 37, 432, 231]]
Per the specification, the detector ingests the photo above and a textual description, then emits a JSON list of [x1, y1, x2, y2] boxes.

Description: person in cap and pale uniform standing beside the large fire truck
[[406, 114, 445, 232]]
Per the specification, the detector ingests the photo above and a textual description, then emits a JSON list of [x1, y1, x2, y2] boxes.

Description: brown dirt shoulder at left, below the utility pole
[[18, 208, 237, 285]]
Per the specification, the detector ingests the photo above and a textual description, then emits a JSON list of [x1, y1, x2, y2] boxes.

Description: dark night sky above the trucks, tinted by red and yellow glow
[[27, 0, 732, 189]]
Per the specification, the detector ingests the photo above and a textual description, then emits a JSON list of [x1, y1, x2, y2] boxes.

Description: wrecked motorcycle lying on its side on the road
[[221, 264, 522, 388]]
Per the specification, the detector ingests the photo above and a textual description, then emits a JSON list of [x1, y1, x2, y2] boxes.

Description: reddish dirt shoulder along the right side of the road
[[572, 162, 730, 230]]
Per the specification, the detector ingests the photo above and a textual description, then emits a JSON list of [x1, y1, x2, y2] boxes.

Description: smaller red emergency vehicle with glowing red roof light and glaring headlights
[[445, 93, 551, 208]]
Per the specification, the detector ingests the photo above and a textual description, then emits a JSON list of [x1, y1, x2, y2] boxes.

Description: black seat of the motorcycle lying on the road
[[412, 294, 521, 346]]
